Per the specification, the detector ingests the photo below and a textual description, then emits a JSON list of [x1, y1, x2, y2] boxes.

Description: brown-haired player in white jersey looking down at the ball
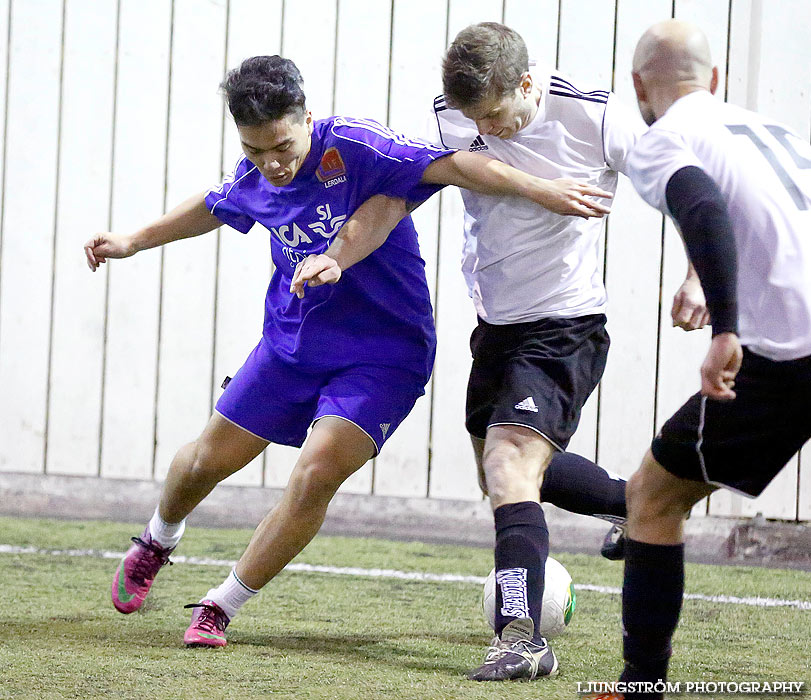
[[434, 22, 703, 681]]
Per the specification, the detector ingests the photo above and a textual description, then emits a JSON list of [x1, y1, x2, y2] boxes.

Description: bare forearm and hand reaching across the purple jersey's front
[[290, 194, 408, 299]]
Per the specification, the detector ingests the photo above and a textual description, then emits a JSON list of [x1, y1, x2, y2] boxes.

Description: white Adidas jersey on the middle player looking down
[[434, 66, 640, 324]]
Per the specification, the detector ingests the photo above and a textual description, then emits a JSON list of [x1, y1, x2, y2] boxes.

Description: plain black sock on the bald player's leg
[[621, 539, 684, 698]]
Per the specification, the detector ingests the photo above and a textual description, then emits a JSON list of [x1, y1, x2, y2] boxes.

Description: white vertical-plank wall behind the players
[[0, 0, 811, 519]]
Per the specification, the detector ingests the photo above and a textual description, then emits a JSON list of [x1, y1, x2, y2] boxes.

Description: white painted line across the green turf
[[0, 544, 811, 610]]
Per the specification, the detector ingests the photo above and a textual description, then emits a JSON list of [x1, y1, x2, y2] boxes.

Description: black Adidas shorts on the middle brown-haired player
[[465, 314, 610, 450]]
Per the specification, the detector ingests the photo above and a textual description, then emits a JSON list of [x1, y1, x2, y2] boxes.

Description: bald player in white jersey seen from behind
[[588, 20, 811, 698]]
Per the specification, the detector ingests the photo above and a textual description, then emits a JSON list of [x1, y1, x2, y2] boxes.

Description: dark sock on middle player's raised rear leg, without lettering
[[541, 452, 627, 518]]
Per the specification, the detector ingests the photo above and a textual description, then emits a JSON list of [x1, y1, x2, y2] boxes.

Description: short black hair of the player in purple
[[220, 56, 307, 126]]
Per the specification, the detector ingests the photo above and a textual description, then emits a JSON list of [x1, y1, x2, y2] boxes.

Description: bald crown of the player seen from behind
[[633, 19, 712, 89]]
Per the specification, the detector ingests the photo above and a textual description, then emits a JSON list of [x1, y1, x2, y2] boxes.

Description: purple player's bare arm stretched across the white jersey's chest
[[422, 151, 614, 219]]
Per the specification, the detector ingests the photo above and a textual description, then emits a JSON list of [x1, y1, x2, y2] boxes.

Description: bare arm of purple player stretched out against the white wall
[[84, 194, 222, 272]]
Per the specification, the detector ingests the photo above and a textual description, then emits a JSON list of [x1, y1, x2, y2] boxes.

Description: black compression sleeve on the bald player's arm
[[665, 166, 738, 335]]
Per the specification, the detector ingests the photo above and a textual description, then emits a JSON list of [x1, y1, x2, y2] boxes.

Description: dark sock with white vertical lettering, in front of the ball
[[494, 501, 549, 641]]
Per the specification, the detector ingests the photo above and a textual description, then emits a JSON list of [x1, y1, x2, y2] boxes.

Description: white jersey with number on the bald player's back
[[629, 90, 811, 361]]
